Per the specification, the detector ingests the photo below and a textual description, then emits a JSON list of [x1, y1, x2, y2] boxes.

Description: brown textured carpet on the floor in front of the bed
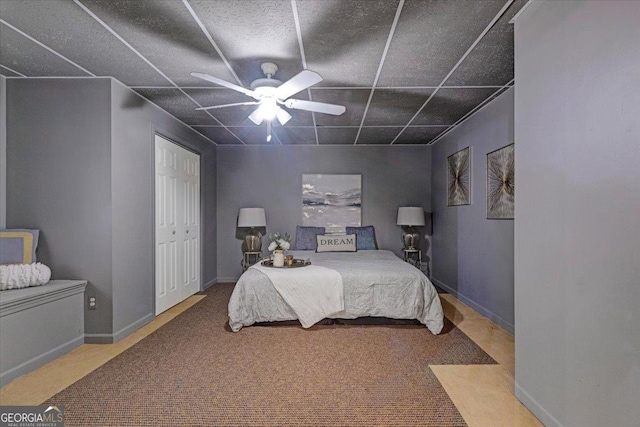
[[45, 285, 495, 427]]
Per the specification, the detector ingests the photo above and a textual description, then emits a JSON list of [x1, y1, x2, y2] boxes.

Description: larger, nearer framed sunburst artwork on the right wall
[[487, 144, 516, 219]]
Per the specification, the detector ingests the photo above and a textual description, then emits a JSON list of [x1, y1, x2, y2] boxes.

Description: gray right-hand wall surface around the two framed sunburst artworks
[[431, 89, 518, 333]]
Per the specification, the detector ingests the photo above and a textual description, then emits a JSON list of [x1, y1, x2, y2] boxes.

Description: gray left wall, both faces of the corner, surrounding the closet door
[[7, 78, 217, 342]]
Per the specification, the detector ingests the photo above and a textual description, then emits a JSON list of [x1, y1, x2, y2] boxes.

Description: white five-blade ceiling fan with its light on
[[191, 62, 346, 125]]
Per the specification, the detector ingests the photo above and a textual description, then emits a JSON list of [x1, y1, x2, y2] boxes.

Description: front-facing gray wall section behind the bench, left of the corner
[[7, 78, 113, 334]]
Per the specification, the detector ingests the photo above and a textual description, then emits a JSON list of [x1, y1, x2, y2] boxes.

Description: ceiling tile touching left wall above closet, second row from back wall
[[135, 88, 219, 125]]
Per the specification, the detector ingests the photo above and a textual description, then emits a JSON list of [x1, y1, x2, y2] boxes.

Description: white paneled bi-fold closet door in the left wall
[[155, 135, 200, 315]]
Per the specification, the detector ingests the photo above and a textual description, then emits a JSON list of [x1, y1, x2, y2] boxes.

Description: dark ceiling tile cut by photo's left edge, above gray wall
[[0, 24, 90, 77]]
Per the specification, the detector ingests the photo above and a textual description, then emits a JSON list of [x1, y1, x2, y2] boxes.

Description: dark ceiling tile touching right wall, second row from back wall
[[411, 88, 496, 125]]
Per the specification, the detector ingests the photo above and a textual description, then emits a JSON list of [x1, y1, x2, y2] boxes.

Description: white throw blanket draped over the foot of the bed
[[250, 264, 344, 328]]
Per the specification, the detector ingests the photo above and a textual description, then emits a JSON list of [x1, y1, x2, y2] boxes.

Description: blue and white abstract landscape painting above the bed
[[302, 174, 362, 233]]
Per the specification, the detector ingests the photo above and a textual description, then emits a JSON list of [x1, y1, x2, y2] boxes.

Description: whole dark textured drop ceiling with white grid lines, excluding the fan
[[0, 0, 527, 146]]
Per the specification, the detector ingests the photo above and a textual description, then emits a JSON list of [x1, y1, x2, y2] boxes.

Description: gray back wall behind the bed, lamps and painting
[[217, 145, 431, 281]]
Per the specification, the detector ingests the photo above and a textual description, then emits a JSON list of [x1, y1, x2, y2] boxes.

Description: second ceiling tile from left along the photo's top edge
[[82, 0, 235, 87]]
